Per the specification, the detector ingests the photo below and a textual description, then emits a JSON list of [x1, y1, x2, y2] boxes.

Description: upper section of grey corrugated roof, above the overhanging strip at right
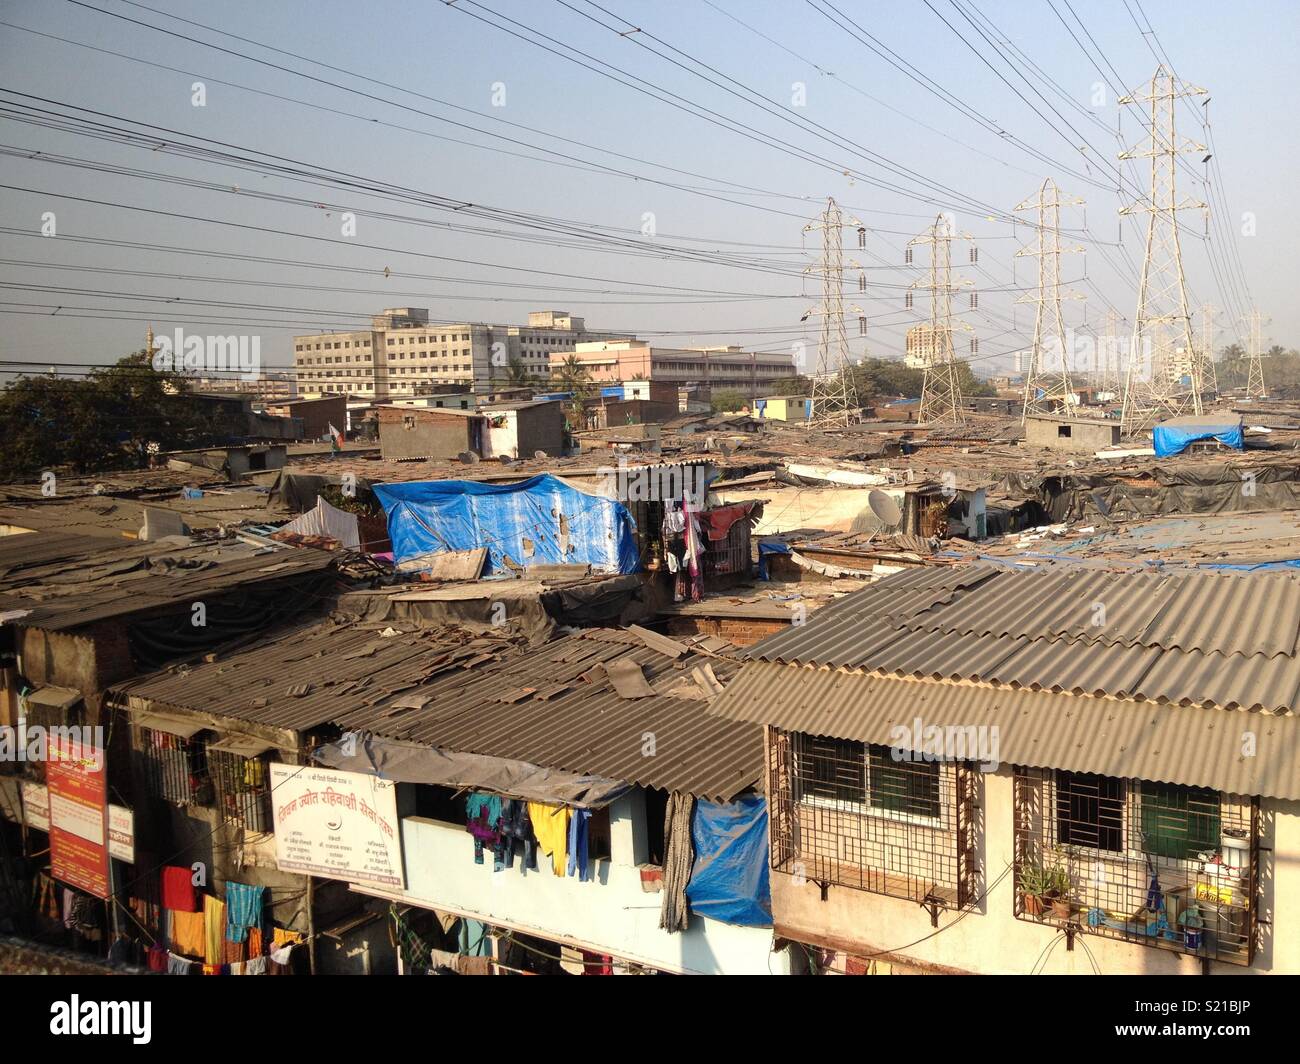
[[746, 565, 1300, 712]]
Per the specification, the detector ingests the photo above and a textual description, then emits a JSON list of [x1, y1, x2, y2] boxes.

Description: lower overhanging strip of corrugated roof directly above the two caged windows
[[710, 662, 1300, 800]]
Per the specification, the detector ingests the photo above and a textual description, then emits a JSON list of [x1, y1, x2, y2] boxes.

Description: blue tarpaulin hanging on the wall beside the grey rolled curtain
[[686, 795, 772, 927]]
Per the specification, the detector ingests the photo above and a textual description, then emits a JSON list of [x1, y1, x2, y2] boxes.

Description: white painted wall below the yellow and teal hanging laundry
[[387, 792, 789, 976]]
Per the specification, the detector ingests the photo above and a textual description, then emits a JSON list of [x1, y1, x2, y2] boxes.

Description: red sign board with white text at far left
[[46, 736, 109, 899]]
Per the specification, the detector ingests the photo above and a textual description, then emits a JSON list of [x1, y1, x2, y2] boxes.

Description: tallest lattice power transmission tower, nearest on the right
[[1119, 65, 1205, 433]]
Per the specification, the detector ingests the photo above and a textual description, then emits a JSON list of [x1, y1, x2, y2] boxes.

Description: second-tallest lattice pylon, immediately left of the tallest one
[[1015, 177, 1096, 424]]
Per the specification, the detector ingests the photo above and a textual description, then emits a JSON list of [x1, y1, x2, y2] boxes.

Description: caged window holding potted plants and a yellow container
[[1014, 767, 1260, 965]]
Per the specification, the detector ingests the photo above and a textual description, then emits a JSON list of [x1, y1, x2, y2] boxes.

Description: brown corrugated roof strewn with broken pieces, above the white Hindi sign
[[112, 624, 763, 801]]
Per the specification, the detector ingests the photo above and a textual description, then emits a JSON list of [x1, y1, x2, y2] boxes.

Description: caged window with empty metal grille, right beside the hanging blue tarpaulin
[[768, 730, 975, 908]]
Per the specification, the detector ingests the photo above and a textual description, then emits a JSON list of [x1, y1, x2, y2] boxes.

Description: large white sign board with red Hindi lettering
[[270, 764, 406, 890]]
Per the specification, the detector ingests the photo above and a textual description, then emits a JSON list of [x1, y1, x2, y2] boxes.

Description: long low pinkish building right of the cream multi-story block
[[551, 339, 796, 395]]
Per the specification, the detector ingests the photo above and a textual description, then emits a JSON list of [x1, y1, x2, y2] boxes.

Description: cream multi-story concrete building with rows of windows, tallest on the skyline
[[294, 307, 624, 399]]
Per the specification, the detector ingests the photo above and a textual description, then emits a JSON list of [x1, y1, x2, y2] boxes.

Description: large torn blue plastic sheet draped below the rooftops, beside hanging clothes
[[374, 473, 640, 572]]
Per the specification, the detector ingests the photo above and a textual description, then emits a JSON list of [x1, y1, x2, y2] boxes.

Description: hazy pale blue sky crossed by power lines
[[0, 0, 1300, 375]]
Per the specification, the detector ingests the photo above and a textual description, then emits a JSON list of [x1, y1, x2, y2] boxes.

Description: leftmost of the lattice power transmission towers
[[803, 198, 867, 425]]
